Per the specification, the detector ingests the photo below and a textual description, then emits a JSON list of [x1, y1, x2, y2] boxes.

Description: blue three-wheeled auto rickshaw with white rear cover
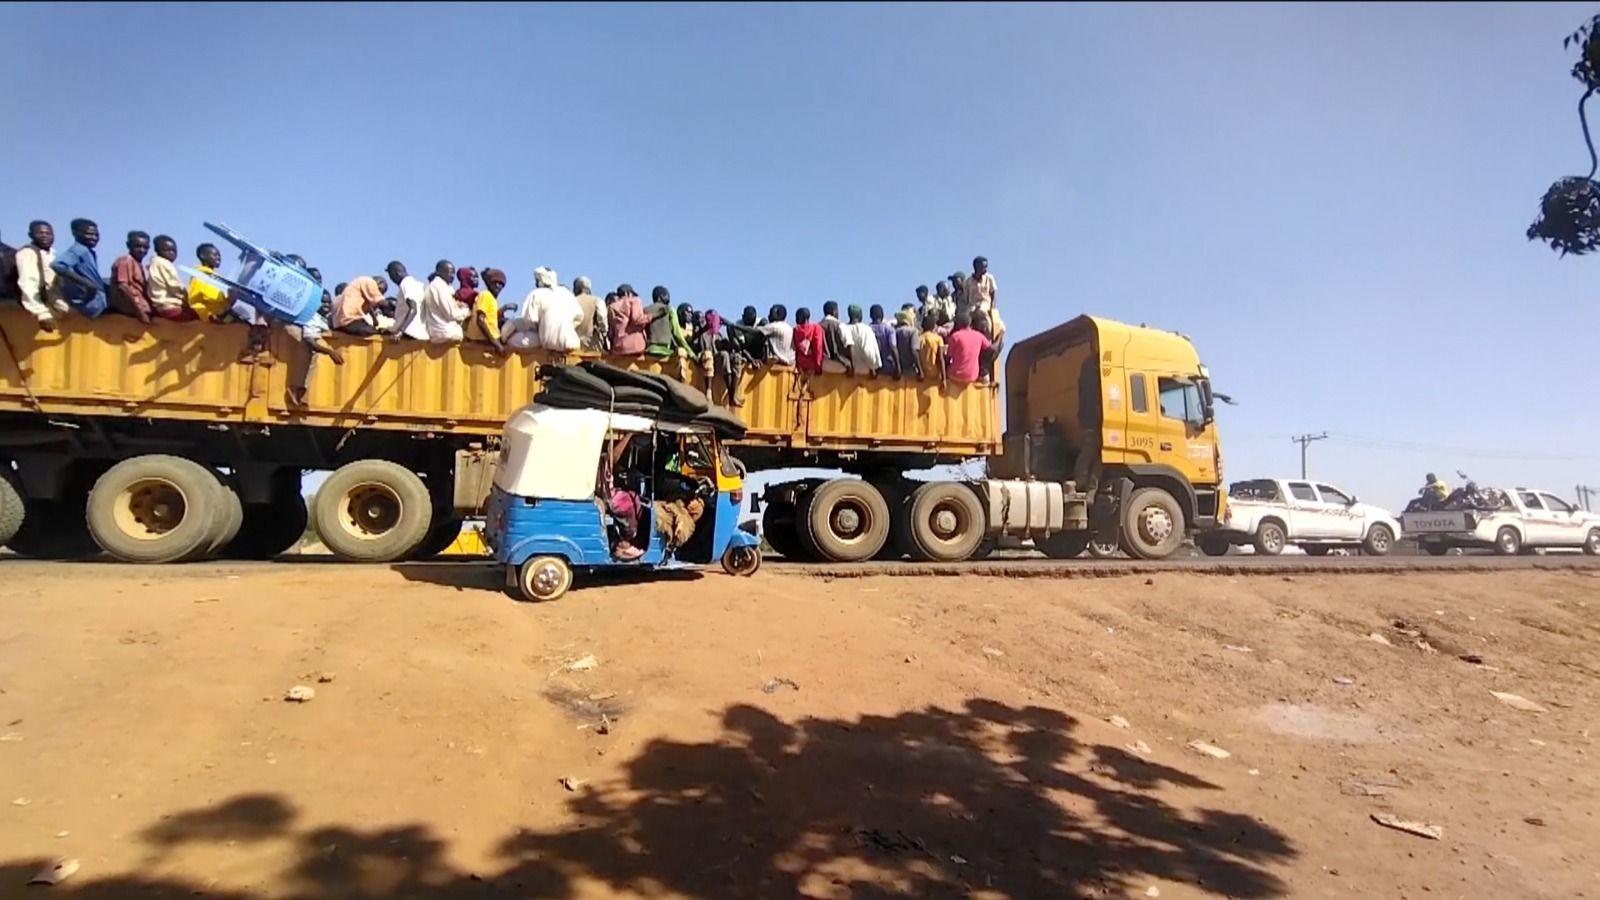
[[483, 404, 762, 601]]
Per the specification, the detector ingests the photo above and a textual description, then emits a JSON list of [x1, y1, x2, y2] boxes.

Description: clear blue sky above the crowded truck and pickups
[[0, 5, 1600, 504]]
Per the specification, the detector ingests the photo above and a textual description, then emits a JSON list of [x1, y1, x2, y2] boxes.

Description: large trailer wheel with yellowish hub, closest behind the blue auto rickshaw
[[312, 460, 434, 562]]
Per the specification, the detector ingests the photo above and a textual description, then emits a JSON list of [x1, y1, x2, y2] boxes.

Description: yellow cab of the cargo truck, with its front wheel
[[990, 315, 1226, 559]]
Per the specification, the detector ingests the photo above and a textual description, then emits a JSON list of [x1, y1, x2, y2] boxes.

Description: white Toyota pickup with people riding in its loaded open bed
[[1400, 487, 1600, 556]]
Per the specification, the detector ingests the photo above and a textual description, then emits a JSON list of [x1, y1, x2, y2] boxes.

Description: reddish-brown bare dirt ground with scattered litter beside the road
[[0, 560, 1600, 898]]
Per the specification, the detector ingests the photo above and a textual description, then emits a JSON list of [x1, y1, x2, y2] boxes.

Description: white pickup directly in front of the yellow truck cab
[[1197, 479, 1400, 556]]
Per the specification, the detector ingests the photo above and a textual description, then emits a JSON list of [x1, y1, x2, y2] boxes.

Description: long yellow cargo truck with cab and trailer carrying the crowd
[[0, 309, 1221, 562]]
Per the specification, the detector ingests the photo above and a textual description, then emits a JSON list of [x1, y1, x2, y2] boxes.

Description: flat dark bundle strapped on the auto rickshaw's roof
[[534, 360, 746, 439]]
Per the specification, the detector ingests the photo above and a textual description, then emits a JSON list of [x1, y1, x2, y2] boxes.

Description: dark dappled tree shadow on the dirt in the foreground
[[0, 700, 1296, 900]]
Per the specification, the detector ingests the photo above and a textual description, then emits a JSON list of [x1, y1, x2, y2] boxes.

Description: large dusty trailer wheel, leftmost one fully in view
[[86, 453, 226, 562]]
